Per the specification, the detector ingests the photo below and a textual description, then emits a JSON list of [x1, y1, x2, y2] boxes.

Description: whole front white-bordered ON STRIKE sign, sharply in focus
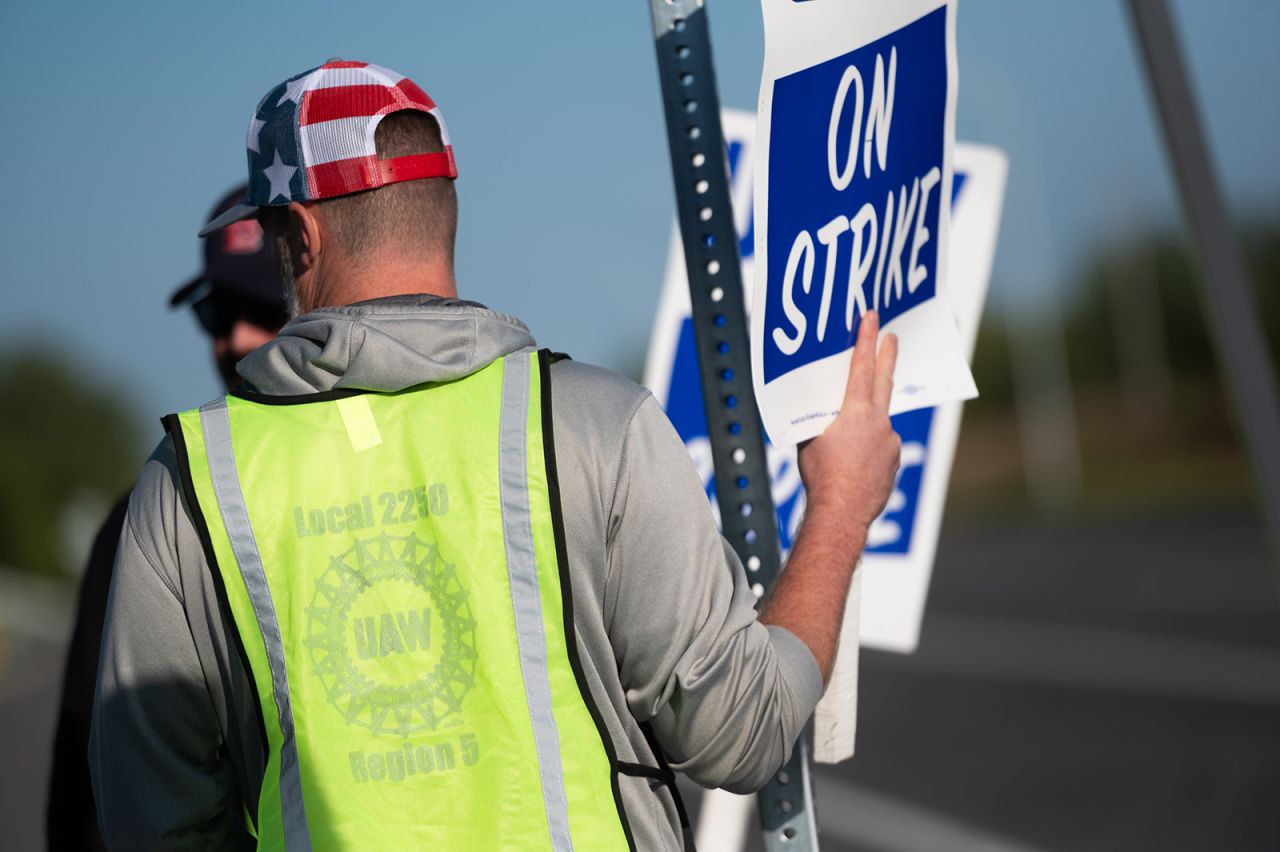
[[751, 0, 977, 444]]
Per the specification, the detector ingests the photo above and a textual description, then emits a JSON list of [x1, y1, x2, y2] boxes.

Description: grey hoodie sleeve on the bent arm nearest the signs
[[604, 397, 822, 792]]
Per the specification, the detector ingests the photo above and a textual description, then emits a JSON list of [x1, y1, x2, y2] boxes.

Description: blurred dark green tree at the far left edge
[[0, 347, 142, 574]]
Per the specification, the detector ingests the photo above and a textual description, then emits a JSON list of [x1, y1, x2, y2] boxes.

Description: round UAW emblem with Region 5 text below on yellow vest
[[306, 524, 479, 782]]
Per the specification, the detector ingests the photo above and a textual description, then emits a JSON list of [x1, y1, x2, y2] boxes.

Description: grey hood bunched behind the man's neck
[[236, 296, 536, 397]]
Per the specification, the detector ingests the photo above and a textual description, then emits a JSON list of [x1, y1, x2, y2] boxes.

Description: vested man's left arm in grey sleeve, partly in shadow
[[88, 443, 253, 849]]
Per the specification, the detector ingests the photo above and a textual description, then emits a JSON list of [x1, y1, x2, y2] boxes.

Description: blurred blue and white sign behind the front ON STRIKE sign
[[645, 101, 1006, 650]]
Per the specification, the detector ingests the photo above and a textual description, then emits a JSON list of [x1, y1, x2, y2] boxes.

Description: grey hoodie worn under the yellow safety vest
[[90, 297, 822, 849]]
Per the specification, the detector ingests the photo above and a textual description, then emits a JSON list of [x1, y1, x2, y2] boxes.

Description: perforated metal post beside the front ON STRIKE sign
[[650, 0, 818, 852]]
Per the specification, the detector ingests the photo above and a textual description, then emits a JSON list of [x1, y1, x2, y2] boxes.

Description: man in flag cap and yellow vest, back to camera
[[91, 60, 899, 851]]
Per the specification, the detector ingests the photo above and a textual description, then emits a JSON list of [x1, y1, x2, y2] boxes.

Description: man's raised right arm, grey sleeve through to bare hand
[[591, 312, 899, 792]]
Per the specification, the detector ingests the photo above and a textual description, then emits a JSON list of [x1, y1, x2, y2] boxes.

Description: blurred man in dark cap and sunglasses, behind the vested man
[[47, 185, 285, 851]]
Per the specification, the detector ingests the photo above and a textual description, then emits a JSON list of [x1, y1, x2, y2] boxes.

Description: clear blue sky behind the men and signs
[[0, 0, 1280, 423]]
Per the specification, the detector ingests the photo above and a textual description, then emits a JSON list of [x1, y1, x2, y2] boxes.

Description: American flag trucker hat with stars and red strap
[[200, 59, 458, 237]]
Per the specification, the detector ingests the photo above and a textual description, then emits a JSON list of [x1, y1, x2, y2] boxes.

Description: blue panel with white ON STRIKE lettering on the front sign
[[763, 6, 947, 383]]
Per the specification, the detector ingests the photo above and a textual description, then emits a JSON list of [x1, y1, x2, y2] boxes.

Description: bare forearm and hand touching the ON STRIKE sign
[[760, 313, 901, 683]]
